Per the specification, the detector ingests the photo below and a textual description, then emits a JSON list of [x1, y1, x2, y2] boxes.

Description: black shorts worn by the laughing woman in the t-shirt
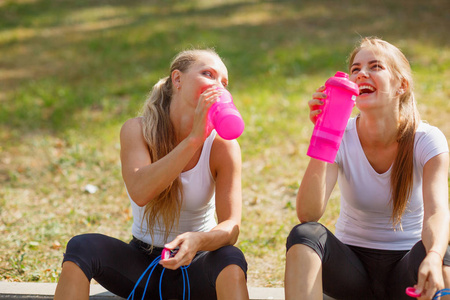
[[286, 222, 450, 300]]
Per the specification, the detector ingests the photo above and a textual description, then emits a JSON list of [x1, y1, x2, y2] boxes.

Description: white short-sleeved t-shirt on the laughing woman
[[335, 118, 449, 250]]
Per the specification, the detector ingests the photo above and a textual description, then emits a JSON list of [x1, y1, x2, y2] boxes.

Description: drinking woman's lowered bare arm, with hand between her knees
[[161, 137, 242, 269]]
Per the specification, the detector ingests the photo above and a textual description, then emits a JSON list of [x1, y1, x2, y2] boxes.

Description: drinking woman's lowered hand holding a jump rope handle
[[160, 232, 202, 270]]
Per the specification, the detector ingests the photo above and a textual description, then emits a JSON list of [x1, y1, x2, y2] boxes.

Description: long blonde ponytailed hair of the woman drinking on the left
[[141, 49, 218, 246]]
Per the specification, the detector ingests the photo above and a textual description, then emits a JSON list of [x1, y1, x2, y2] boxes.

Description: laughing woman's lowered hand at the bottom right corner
[[414, 252, 444, 300]]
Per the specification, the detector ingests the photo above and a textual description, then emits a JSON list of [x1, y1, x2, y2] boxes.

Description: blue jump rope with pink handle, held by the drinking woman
[[127, 248, 191, 300]]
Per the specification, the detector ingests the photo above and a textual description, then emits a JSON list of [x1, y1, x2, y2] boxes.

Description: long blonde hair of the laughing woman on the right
[[349, 37, 420, 228]]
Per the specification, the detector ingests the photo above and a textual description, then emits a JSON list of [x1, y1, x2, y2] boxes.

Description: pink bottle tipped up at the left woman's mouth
[[208, 89, 245, 140]]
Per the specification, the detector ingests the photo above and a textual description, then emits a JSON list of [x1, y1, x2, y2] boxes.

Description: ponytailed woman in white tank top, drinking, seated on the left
[[55, 50, 248, 300]]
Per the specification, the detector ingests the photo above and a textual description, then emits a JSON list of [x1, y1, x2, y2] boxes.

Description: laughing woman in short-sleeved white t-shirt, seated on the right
[[285, 38, 450, 300]]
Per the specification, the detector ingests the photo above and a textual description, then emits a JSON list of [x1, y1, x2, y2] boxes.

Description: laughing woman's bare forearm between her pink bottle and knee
[[296, 158, 338, 223]]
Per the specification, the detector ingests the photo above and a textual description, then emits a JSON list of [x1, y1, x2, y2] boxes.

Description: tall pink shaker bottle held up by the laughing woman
[[307, 72, 359, 163]]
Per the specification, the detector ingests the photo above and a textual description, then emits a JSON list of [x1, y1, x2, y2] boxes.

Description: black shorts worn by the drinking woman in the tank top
[[63, 234, 247, 299]]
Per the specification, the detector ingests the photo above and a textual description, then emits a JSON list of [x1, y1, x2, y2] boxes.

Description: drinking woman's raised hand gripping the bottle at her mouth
[[191, 86, 222, 141]]
